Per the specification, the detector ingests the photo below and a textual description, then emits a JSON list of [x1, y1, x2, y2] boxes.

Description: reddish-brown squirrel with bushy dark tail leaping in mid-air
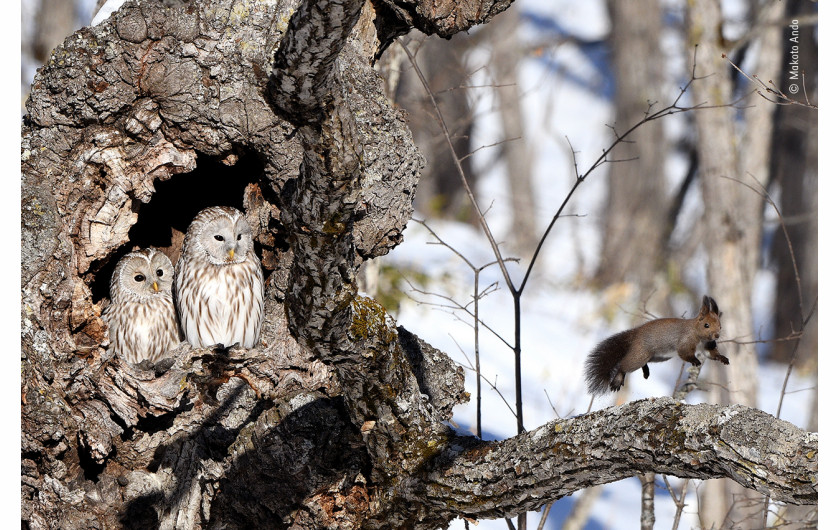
[[586, 296, 729, 395]]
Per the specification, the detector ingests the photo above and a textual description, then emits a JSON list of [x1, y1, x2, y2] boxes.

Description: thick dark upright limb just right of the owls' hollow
[[272, 1, 450, 524]]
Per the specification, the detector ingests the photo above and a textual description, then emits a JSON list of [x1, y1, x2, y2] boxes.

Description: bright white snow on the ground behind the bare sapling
[[382, 0, 815, 530]]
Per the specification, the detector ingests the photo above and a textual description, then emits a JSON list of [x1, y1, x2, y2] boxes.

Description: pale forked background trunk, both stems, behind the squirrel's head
[[687, 0, 784, 527]]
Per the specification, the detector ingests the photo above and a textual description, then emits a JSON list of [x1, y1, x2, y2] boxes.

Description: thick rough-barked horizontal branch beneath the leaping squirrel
[[417, 398, 818, 518]]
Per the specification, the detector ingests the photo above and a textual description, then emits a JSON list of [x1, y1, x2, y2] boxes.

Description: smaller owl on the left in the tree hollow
[[102, 248, 180, 363]]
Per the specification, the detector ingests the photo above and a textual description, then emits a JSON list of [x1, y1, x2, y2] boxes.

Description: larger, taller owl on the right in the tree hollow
[[175, 206, 263, 348]]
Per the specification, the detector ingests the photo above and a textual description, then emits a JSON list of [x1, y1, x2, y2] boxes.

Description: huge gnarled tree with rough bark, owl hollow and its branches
[[21, 0, 817, 529]]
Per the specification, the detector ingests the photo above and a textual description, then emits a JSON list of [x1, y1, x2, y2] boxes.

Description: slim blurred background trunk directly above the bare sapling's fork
[[488, 4, 537, 256]]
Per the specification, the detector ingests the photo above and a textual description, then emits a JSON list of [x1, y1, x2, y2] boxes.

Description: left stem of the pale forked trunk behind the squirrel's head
[[686, 0, 740, 528]]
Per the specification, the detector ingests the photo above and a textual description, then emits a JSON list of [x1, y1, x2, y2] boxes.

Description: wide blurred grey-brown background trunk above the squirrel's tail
[[597, 0, 668, 297]]
